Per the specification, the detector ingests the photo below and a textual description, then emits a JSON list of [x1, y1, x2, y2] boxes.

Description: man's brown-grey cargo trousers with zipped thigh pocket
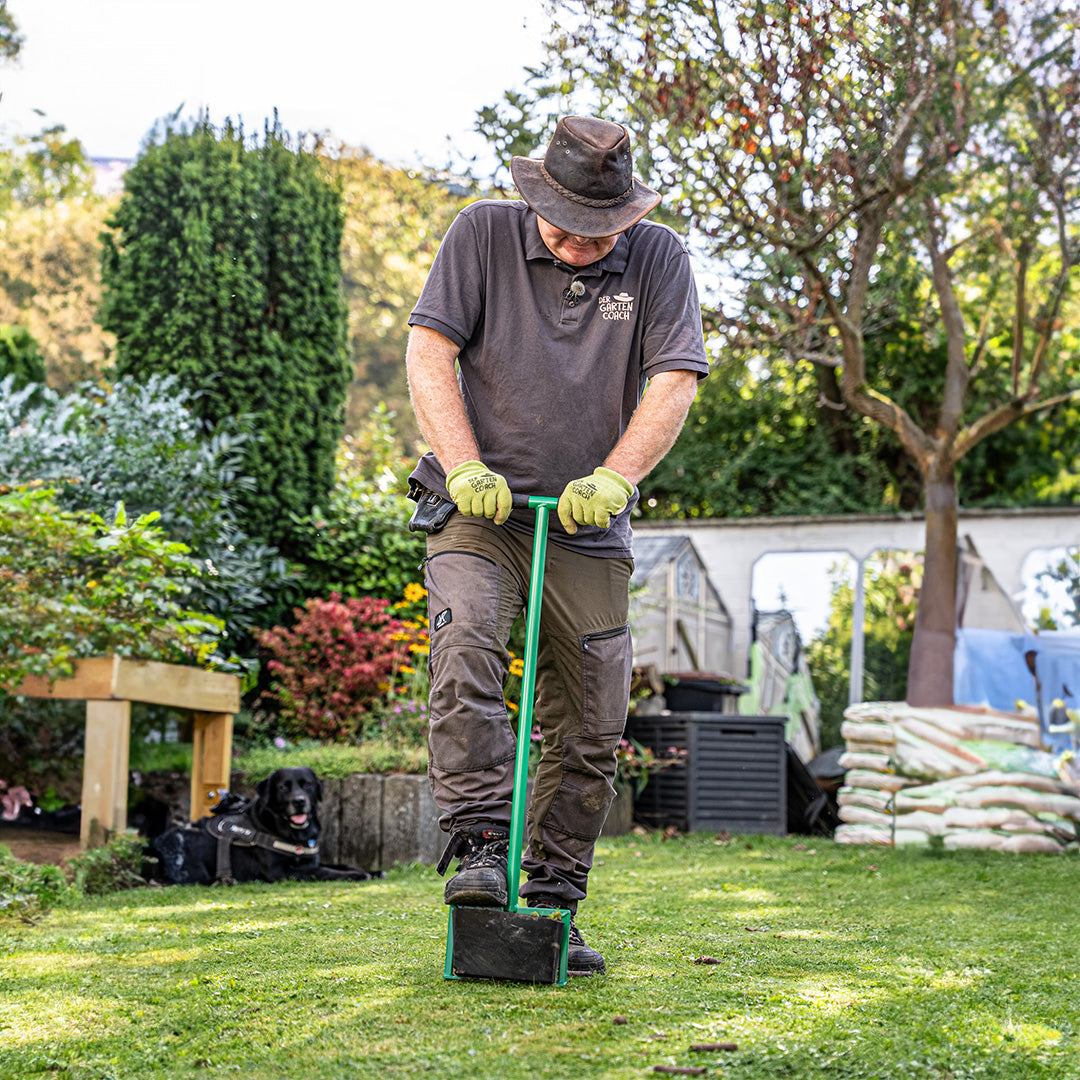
[[424, 514, 633, 910]]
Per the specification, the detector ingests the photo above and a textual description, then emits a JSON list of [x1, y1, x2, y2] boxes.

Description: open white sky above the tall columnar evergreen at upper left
[[0, 0, 550, 166]]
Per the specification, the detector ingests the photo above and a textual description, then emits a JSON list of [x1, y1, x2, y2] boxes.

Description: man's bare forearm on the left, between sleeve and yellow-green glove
[[405, 326, 480, 472]]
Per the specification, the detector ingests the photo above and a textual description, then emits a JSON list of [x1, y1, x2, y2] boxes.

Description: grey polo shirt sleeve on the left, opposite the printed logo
[[408, 212, 484, 349]]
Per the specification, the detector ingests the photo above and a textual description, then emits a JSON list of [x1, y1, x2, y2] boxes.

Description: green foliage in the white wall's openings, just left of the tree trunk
[[807, 552, 922, 750]]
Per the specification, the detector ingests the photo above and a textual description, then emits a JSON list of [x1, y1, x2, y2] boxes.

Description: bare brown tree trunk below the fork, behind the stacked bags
[[907, 462, 957, 705]]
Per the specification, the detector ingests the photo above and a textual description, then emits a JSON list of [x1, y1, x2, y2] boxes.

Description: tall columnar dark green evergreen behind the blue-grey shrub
[[102, 120, 349, 554]]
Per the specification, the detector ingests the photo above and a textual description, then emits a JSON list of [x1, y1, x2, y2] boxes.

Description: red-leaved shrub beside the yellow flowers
[[257, 593, 403, 739]]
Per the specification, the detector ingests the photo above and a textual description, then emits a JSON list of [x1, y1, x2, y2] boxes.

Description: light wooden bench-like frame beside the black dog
[[14, 657, 240, 848]]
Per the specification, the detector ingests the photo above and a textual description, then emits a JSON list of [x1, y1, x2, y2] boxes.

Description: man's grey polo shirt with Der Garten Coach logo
[[409, 200, 708, 557]]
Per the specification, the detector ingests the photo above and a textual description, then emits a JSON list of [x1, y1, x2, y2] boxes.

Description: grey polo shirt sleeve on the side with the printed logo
[[642, 234, 708, 379]]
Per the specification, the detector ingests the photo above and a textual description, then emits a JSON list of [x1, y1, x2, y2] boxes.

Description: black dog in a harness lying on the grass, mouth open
[[149, 769, 382, 885]]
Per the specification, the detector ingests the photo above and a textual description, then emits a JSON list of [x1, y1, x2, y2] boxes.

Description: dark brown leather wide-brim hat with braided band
[[510, 117, 660, 237]]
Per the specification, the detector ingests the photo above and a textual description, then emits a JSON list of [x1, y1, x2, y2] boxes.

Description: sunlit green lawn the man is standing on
[[0, 835, 1080, 1080]]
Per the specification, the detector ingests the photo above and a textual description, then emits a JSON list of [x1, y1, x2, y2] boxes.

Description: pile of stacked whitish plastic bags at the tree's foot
[[835, 702, 1080, 852]]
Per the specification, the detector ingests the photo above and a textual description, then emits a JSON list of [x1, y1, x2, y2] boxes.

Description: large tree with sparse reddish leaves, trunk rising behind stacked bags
[[482, 0, 1080, 704]]
